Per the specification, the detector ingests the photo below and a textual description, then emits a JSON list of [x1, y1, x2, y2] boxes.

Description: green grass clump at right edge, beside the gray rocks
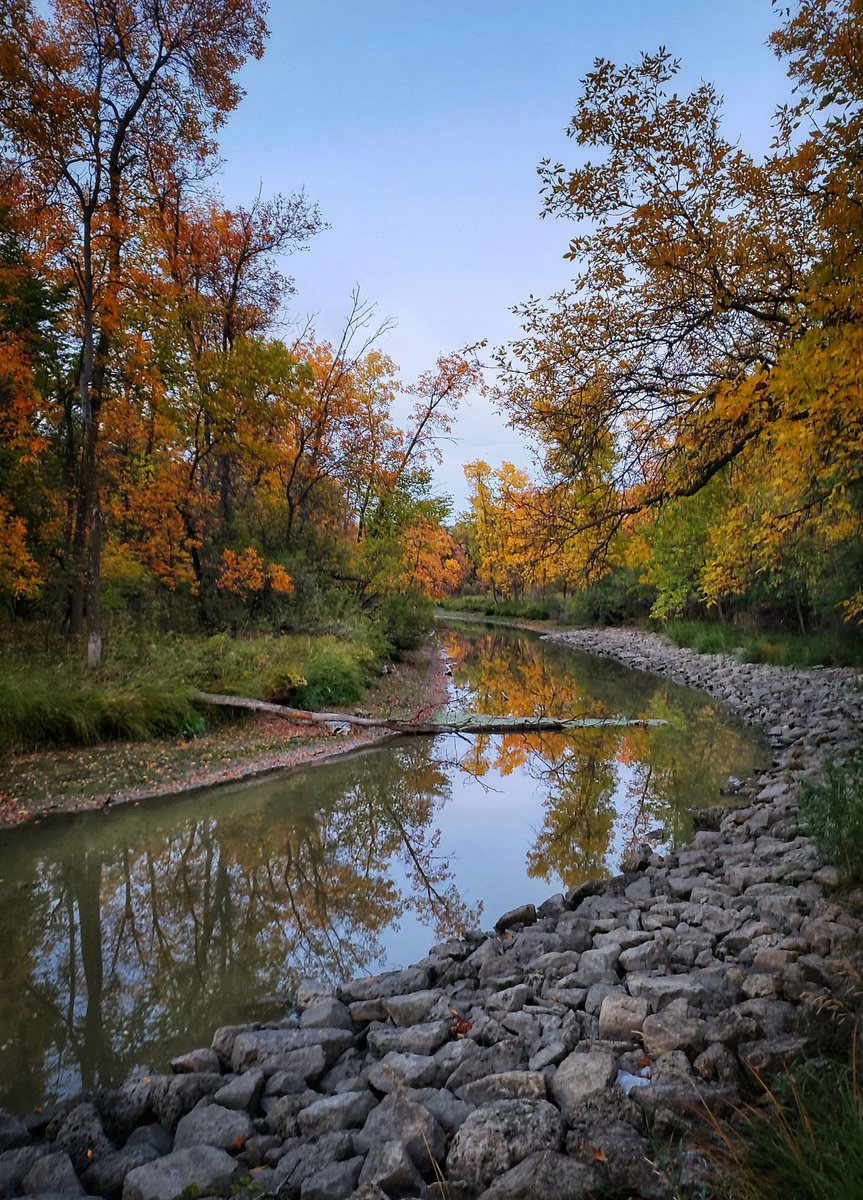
[[799, 745, 863, 887]]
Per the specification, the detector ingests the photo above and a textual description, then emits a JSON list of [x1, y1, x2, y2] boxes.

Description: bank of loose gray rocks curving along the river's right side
[[0, 632, 863, 1200]]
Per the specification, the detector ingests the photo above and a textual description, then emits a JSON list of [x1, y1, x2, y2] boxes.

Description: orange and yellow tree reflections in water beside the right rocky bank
[[443, 629, 762, 888]]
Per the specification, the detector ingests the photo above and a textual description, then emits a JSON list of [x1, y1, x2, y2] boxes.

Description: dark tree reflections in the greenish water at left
[[0, 739, 480, 1109]]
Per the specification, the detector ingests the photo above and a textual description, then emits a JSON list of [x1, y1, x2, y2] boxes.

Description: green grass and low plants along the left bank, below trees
[[0, 634, 379, 752]]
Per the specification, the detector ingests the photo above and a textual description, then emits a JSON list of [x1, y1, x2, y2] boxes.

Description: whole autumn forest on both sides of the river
[[0, 0, 863, 748]]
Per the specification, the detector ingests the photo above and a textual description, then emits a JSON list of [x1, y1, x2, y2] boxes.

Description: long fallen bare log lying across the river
[[192, 691, 665, 733]]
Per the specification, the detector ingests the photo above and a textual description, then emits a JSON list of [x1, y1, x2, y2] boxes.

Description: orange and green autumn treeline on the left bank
[[0, 0, 475, 665]]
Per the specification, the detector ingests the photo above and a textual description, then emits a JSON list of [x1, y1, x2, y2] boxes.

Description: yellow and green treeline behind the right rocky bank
[[462, 0, 863, 630]]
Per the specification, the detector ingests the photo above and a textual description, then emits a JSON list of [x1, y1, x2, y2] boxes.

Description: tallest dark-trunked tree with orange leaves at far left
[[0, 0, 266, 664]]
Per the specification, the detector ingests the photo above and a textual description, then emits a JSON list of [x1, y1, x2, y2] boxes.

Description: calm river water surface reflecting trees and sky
[[0, 624, 765, 1112]]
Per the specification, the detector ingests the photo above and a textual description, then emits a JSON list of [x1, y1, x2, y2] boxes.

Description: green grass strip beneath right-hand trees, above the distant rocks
[[658, 620, 863, 667]]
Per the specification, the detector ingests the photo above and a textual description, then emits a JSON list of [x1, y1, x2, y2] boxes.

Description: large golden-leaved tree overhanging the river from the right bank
[[499, 0, 863, 610]]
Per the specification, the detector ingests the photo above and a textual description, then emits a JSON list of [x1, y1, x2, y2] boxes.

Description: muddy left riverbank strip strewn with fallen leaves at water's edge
[[0, 646, 456, 829]]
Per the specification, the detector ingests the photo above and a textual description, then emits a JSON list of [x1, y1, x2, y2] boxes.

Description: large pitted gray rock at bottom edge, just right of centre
[[447, 1099, 563, 1189]]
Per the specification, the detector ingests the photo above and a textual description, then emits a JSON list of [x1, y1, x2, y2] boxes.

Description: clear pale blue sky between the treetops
[[218, 0, 787, 510]]
